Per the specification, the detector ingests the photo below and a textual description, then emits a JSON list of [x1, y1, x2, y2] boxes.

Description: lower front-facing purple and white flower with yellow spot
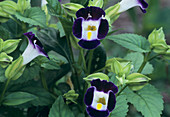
[[84, 79, 118, 117]]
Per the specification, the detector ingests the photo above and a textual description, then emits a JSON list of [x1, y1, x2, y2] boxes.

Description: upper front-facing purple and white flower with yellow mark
[[73, 6, 109, 49]]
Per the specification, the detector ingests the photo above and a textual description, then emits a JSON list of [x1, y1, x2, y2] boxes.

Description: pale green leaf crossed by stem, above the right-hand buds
[[125, 52, 154, 74]]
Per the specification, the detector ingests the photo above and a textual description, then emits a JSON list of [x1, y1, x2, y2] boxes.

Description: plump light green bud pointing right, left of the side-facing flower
[[2, 39, 21, 54]]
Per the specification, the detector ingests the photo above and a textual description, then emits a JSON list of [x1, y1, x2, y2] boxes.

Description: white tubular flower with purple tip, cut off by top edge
[[118, 0, 148, 13]]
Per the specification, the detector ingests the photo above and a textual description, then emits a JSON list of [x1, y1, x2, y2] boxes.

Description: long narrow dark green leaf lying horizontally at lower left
[[3, 92, 37, 106]]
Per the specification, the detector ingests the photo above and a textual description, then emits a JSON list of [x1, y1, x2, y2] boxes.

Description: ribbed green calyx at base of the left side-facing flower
[[5, 56, 25, 80]]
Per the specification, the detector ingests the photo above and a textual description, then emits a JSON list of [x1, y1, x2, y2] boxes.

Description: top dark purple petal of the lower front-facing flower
[[91, 79, 118, 93]]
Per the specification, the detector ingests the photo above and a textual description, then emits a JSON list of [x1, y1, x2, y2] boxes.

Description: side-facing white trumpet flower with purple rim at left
[[22, 32, 49, 65]]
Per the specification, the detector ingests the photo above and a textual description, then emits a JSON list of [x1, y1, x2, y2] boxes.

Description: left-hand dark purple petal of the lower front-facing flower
[[84, 87, 94, 106]]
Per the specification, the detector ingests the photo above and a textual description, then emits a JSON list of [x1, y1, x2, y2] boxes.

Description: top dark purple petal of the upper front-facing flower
[[76, 6, 105, 20]]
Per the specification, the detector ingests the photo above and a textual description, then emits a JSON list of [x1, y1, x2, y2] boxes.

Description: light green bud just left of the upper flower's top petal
[[62, 3, 84, 18]]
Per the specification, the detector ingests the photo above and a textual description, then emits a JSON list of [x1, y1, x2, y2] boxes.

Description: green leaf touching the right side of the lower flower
[[110, 95, 128, 117]]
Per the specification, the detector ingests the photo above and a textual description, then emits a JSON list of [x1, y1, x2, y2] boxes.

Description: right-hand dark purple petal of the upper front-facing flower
[[97, 19, 109, 39]]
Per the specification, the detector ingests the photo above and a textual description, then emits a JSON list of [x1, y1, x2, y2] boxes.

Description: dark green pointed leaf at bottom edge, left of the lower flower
[[48, 96, 74, 117]]
